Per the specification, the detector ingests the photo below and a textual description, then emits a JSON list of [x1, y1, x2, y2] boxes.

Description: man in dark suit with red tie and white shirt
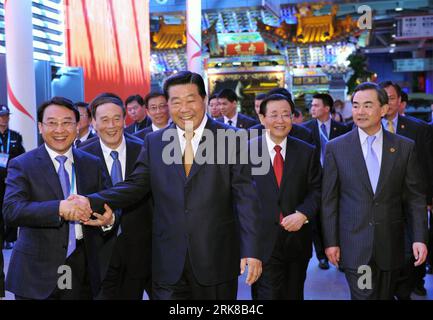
[[250, 94, 321, 300]]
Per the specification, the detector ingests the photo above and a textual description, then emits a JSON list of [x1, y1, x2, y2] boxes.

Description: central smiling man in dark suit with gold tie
[[69, 71, 261, 299]]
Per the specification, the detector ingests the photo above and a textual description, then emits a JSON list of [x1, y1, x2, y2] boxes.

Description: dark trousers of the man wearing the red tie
[[251, 230, 310, 300]]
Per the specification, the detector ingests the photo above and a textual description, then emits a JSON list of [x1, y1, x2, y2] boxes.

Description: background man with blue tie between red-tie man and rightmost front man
[[304, 93, 347, 270]]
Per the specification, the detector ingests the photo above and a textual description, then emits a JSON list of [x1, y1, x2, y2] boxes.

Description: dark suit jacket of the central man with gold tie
[[89, 119, 260, 285]]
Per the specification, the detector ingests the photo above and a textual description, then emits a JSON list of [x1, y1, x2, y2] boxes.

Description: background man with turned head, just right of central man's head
[[217, 89, 259, 129]]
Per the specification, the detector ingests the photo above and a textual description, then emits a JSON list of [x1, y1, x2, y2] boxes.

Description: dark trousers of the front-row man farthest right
[[344, 261, 400, 300]]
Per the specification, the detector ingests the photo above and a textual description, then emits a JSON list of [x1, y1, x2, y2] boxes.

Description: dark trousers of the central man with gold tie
[[152, 253, 236, 300]]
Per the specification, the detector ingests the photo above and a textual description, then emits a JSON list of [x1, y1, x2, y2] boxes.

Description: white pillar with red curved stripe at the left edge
[[5, 0, 37, 151]]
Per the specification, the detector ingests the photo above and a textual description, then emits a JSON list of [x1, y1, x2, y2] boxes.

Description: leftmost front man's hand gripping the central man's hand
[[59, 195, 92, 222]]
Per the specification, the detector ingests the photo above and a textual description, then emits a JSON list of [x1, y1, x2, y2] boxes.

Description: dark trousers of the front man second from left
[[97, 241, 152, 300]]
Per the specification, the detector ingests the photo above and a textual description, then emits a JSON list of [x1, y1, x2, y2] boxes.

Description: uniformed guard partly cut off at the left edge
[[0, 105, 26, 249]]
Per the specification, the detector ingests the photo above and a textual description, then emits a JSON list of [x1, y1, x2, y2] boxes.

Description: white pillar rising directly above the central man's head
[[186, 0, 203, 75]]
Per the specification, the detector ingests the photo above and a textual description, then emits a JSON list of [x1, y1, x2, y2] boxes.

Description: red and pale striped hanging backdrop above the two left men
[[65, 0, 150, 124]]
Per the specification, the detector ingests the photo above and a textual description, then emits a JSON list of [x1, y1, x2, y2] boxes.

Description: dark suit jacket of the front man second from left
[[81, 138, 152, 278]]
